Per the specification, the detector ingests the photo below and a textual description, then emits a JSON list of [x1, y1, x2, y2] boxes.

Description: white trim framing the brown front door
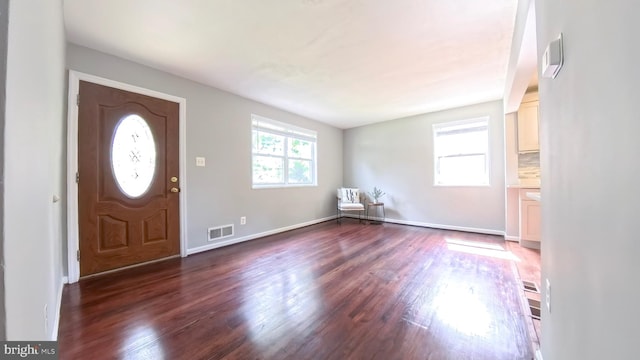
[[67, 70, 187, 284]]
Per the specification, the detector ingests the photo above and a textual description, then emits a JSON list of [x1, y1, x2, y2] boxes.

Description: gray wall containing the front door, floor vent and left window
[[67, 44, 342, 253]]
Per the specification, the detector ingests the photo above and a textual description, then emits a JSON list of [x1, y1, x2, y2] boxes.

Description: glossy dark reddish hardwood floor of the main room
[[58, 219, 533, 360]]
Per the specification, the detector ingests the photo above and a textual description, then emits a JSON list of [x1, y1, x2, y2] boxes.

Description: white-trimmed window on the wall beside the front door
[[251, 115, 317, 188]]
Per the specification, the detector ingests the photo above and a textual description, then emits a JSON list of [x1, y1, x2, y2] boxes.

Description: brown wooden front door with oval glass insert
[[78, 81, 180, 276]]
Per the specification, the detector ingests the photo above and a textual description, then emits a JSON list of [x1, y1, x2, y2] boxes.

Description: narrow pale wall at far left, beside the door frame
[[4, 0, 65, 340]]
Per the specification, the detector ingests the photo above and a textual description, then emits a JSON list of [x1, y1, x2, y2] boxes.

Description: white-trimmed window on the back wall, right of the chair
[[433, 117, 489, 186]]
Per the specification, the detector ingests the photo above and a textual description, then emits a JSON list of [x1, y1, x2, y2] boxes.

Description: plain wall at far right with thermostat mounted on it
[[536, 0, 640, 360]]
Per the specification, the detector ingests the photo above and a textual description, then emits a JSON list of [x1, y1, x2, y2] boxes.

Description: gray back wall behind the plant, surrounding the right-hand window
[[344, 101, 505, 233]]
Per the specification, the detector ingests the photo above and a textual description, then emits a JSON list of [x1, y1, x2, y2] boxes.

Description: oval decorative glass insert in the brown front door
[[111, 114, 156, 198]]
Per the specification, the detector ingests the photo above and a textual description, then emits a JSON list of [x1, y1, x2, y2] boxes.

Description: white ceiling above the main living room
[[64, 0, 517, 129]]
